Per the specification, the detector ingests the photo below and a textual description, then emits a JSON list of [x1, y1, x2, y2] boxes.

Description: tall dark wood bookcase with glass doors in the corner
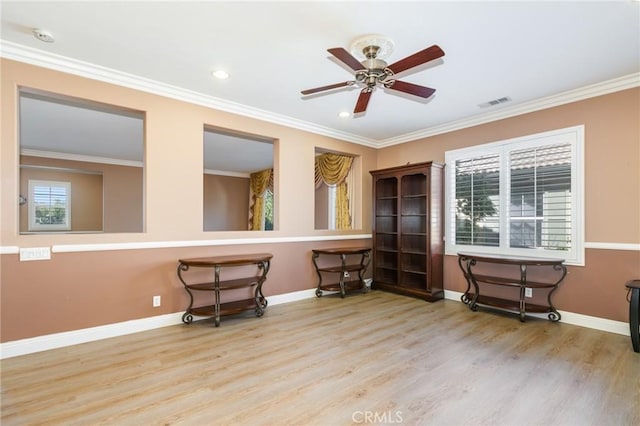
[[370, 162, 444, 302]]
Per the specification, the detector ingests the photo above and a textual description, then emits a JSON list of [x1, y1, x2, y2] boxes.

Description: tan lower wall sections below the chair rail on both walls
[[0, 239, 640, 342]]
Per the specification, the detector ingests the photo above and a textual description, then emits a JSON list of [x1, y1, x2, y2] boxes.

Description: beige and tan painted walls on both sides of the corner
[[0, 59, 640, 342]]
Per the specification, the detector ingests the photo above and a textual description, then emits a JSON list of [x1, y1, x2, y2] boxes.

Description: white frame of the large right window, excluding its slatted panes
[[445, 125, 585, 266]]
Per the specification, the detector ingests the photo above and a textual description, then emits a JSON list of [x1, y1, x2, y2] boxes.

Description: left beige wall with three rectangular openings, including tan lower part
[[0, 59, 377, 342]]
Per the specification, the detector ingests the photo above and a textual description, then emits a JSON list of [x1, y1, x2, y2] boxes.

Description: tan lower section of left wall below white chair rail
[[0, 240, 371, 342]]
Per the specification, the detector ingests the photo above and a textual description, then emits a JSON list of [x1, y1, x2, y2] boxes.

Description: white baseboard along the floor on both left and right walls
[[0, 288, 630, 359]]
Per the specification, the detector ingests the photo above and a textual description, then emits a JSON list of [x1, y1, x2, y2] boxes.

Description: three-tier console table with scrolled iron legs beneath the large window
[[458, 253, 567, 322]]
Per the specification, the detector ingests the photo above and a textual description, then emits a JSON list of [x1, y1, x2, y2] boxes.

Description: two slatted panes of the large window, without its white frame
[[455, 144, 572, 250]]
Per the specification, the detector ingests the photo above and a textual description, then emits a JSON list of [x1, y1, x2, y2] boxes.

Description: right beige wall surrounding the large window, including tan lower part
[[378, 88, 640, 321]]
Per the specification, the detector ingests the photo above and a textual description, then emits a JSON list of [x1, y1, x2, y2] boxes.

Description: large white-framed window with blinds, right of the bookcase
[[445, 126, 584, 264]]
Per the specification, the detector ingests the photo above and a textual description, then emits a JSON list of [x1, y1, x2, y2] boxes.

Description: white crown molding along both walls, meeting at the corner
[[0, 39, 640, 148]]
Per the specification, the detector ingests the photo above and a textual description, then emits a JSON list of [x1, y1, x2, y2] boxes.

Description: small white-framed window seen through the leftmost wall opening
[[27, 180, 71, 231]]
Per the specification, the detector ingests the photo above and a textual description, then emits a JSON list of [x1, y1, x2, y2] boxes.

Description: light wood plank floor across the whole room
[[1, 291, 640, 426]]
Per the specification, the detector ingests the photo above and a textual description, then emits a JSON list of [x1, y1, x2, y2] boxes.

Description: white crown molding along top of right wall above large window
[[378, 72, 640, 148]]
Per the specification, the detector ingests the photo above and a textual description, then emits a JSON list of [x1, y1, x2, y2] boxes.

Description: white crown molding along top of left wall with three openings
[[0, 39, 377, 148]]
